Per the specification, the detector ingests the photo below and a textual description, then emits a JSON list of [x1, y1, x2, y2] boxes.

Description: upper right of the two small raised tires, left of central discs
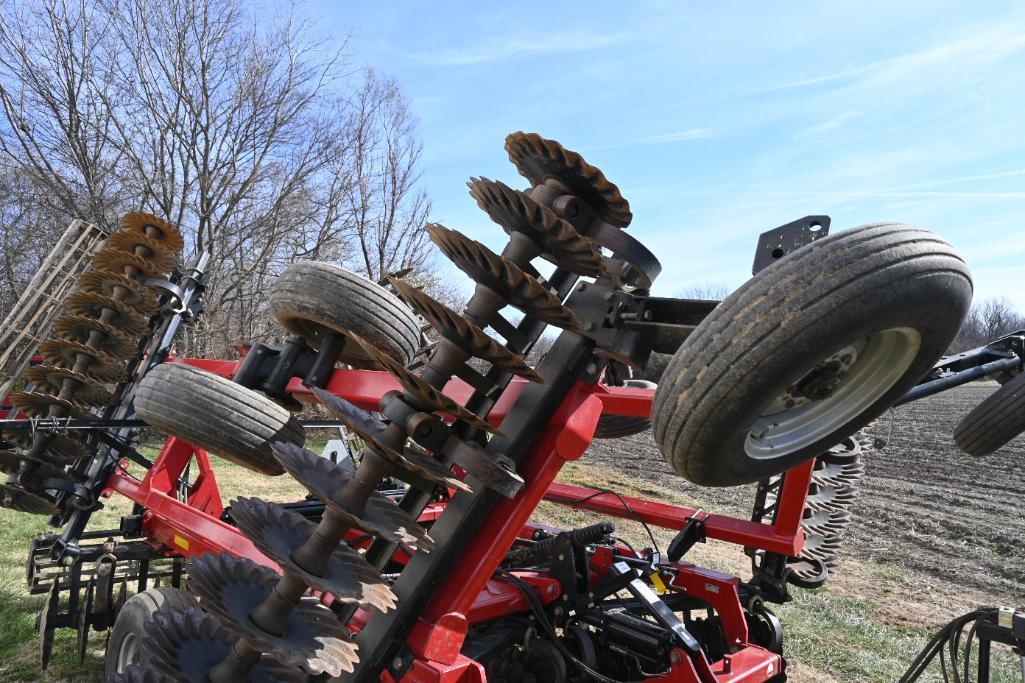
[[271, 262, 420, 367]]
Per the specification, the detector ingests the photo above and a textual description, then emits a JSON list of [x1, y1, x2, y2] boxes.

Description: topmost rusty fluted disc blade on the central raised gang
[[505, 131, 633, 228]]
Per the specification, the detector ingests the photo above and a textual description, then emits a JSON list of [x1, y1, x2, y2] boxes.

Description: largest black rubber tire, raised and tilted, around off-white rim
[[652, 224, 972, 486]]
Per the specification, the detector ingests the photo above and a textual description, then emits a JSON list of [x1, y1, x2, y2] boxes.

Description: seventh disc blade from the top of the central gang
[[271, 442, 435, 552]]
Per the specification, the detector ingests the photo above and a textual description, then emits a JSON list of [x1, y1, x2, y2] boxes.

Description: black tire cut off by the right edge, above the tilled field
[[954, 372, 1025, 457]]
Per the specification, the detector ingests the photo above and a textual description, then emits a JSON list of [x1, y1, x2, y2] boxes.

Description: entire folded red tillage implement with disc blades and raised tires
[[0, 133, 1025, 683]]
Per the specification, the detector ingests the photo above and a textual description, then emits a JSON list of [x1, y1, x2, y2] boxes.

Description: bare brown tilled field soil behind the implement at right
[[584, 385, 1025, 603]]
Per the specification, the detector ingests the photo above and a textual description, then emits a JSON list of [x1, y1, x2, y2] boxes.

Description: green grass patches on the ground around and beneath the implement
[[0, 444, 1021, 683]]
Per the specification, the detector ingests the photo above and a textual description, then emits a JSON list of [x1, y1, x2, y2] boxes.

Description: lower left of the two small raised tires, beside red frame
[[135, 363, 305, 476]]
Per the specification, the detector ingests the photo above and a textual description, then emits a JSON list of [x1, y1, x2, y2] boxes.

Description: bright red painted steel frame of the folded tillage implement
[[96, 352, 814, 683]]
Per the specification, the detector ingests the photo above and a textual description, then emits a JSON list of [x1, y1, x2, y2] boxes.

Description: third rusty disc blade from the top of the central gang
[[425, 224, 580, 330]]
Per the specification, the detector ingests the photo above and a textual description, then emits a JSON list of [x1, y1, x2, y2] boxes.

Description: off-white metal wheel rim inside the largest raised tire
[[744, 327, 921, 460]]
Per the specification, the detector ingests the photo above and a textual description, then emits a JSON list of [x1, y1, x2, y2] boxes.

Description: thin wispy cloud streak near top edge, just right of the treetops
[[404, 32, 634, 67]]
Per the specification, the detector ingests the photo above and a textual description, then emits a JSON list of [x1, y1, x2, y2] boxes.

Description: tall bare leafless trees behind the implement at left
[[0, 0, 433, 356]]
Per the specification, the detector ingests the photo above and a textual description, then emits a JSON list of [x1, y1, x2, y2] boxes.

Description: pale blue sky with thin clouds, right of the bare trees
[[305, 0, 1025, 310]]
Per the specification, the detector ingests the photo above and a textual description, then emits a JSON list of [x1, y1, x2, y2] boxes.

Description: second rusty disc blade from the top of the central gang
[[467, 177, 605, 277]]
